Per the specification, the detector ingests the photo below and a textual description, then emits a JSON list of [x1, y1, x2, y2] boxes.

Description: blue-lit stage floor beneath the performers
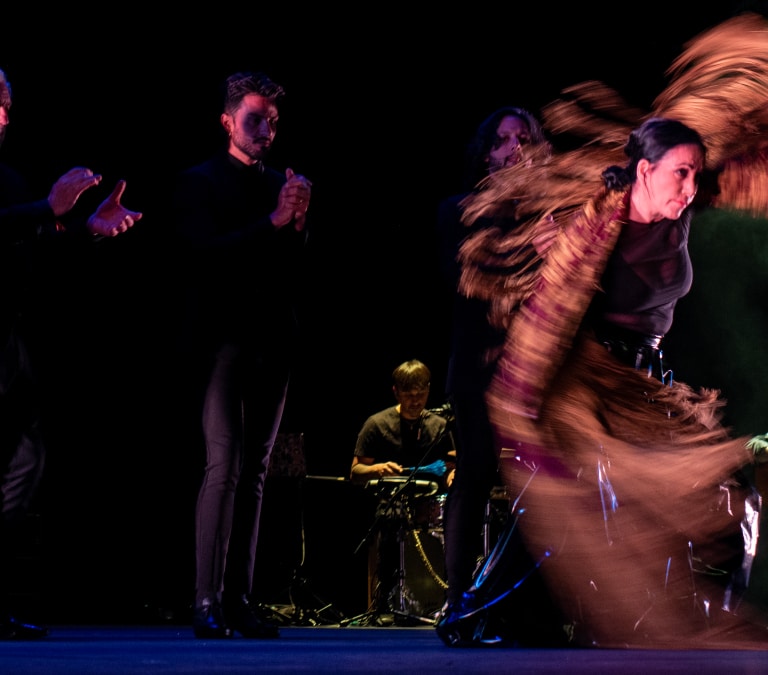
[[0, 625, 768, 675]]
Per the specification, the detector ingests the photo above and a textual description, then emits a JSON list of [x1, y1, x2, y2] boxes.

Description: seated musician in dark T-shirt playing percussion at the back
[[350, 360, 456, 624]]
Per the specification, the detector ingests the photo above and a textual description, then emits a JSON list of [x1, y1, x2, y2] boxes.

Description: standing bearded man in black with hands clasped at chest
[[174, 72, 311, 638]]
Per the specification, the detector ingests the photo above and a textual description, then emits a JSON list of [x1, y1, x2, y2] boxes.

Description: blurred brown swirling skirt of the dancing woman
[[488, 335, 768, 649]]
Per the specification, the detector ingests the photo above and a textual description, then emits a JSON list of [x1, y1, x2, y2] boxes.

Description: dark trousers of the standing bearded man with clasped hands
[[195, 343, 290, 606]]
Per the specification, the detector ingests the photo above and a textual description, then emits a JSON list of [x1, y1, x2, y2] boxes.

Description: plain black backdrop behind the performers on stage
[[0, 1, 768, 620]]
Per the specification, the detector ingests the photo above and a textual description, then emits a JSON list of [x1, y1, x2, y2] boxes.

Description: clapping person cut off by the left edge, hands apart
[[0, 70, 142, 640]]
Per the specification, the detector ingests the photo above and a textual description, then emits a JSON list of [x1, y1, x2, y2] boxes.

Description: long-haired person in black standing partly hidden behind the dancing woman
[[437, 106, 547, 607]]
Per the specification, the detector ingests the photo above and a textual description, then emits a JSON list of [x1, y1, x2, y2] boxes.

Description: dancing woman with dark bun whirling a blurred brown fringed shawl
[[436, 13, 768, 649]]
